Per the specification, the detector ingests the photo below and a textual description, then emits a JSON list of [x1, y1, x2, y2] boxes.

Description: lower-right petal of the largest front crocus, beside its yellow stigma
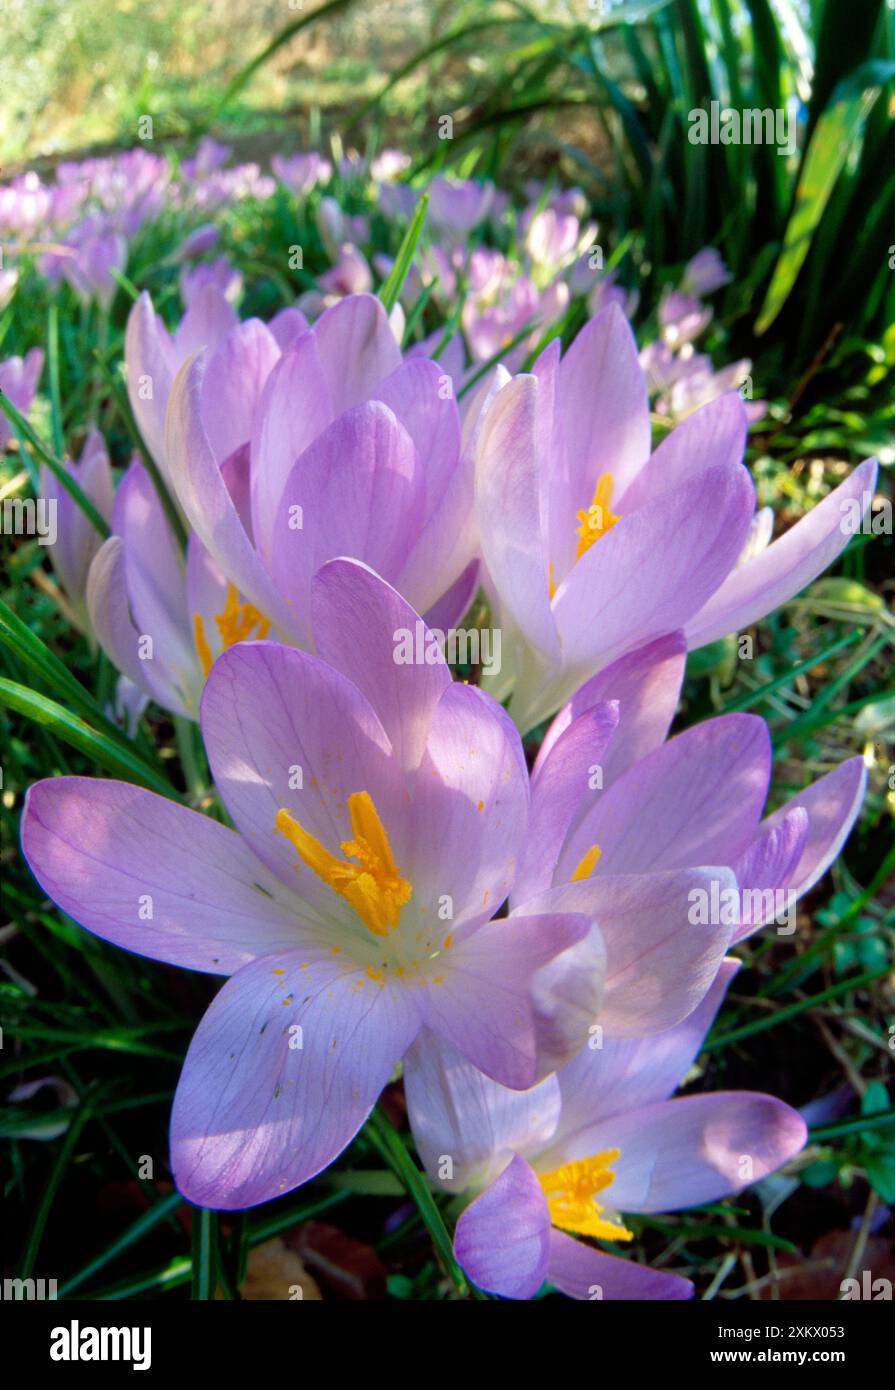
[[421, 912, 596, 1090]]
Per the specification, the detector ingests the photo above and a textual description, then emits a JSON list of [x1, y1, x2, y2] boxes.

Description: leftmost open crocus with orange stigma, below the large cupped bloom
[[86, 453, 271, 720]]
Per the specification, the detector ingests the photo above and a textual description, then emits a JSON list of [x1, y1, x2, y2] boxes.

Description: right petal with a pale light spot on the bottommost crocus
[[567, 1091, 807, 1212]]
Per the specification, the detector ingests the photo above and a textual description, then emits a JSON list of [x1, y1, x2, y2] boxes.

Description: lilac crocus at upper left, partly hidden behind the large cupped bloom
[[125, 282, 307, 482]]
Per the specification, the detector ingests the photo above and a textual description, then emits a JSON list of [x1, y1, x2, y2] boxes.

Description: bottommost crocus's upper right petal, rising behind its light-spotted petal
[[553, 959, 739, 1150]]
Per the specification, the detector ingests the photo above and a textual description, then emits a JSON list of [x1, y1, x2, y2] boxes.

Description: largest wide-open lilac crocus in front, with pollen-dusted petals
[[22, 560, 602, 1208]]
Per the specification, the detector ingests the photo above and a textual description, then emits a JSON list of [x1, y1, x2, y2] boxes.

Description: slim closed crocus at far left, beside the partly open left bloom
[[40, 430, 114, 632]]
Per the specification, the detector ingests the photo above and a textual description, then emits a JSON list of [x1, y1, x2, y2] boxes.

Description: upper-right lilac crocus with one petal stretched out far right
[[475, 304, 876, 730]]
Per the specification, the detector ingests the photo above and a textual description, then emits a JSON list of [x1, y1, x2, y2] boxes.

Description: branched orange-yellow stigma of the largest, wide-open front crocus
[[277, 791, 413, 937]]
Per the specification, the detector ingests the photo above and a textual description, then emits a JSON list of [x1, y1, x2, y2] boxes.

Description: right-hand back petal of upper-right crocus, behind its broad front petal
[[616, 391, 749, 514]]
